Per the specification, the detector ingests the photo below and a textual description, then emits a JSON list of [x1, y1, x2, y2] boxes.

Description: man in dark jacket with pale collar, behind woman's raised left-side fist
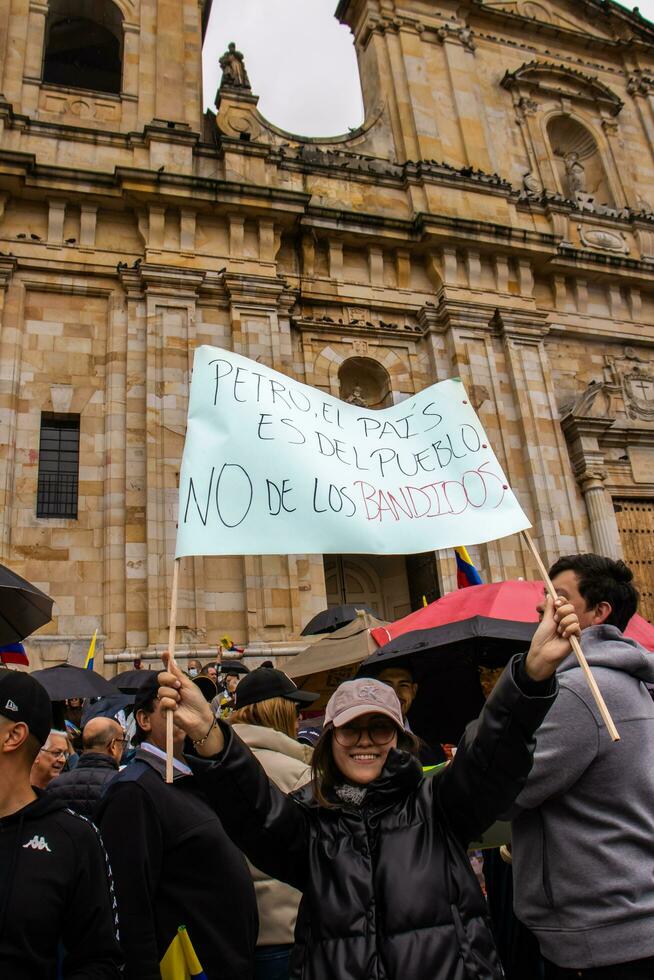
[[98, 671, 258, 980]]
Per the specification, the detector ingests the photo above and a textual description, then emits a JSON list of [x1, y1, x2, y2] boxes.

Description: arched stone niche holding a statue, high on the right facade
[[547, 116, 615, 207]]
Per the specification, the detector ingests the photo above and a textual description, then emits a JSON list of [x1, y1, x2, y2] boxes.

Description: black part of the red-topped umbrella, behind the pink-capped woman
[[359, 616, 538, 744]]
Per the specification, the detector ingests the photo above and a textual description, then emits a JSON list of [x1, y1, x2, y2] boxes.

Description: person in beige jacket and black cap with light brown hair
[[229, 667, 319, 980]]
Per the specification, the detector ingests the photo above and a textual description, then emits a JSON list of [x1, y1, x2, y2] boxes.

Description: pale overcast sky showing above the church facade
[[204, 0, 654, 136]]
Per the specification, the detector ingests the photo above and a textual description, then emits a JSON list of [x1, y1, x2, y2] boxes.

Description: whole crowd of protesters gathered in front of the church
[[0, 555, 654, 980]]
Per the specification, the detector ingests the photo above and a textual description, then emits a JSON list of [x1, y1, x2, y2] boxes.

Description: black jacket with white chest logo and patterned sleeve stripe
[[0, 794, 122, 980]]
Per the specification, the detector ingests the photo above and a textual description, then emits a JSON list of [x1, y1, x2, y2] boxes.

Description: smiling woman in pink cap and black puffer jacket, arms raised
[[159, 599, 580, 980]]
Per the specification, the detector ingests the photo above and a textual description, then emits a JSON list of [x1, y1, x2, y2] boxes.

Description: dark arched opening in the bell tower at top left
[[43, 0, 123, 94]]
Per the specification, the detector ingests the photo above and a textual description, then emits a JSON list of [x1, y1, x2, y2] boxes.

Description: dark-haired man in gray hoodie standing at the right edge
[[512, 555, 654, 980]]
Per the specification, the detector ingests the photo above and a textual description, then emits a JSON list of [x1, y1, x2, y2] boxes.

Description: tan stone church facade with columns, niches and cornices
[[0, 0, 654, 673]]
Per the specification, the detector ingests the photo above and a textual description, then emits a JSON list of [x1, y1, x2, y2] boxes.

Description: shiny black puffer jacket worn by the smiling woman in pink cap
[[191, 661, 556, 980]]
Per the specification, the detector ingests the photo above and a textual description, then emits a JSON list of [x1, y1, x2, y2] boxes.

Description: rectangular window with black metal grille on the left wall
[[36, 412, 79, 519]]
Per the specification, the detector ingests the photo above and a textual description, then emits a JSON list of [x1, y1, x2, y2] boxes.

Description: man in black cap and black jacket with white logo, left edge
[[0, 671, 122, 980]]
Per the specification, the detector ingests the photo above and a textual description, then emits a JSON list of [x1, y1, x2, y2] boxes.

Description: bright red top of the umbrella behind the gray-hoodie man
[[371, 581, 654, 652]]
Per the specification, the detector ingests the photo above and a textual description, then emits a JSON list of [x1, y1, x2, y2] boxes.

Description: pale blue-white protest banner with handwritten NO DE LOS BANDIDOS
[[177, 346, 530, 558]]
